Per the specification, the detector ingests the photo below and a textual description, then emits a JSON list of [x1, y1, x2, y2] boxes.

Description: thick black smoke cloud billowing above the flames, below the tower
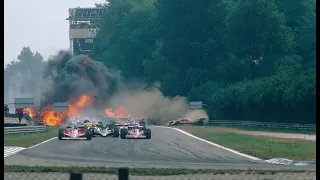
[[41, 51, 119, 107]]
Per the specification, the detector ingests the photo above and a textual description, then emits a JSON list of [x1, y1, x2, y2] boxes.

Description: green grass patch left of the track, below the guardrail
[[4, 127, 59, 147]]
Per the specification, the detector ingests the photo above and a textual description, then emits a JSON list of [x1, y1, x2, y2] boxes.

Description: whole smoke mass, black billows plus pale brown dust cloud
[[42, 51, 208, 124]]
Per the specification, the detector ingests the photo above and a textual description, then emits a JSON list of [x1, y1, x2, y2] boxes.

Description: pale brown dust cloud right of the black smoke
[[111, 88, 208, 125]]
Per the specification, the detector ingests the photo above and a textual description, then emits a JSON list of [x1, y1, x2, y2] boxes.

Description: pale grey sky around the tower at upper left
[[4, 0, 105, 67]]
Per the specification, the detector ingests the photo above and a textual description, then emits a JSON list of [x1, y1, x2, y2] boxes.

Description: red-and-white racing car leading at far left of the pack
[[58, 125, 92, 140]]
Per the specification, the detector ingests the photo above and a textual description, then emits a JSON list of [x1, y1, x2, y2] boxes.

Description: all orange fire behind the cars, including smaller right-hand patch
[[29, 94, 130, 126]]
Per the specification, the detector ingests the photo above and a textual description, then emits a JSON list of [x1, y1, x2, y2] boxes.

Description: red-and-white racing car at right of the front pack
[[120, 125, 151, 139]]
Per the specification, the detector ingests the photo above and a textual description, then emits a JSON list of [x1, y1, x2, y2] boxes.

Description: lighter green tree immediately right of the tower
[[92, 0, 157, 78]]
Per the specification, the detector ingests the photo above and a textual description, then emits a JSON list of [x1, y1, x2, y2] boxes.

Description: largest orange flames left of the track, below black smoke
[[41, 94, 92, 126]]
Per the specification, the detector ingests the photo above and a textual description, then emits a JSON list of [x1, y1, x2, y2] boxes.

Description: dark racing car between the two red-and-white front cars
[[89, 122, 120, 138]]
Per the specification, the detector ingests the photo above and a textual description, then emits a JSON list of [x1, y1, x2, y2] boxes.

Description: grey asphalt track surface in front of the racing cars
[[4, 126, 316, 170]]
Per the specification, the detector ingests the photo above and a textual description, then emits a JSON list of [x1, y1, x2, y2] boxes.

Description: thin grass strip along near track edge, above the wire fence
[[4, 165, 310, 176]]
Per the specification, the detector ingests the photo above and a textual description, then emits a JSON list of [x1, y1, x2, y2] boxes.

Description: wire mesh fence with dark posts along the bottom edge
[[4, 169, 316, 180]]
